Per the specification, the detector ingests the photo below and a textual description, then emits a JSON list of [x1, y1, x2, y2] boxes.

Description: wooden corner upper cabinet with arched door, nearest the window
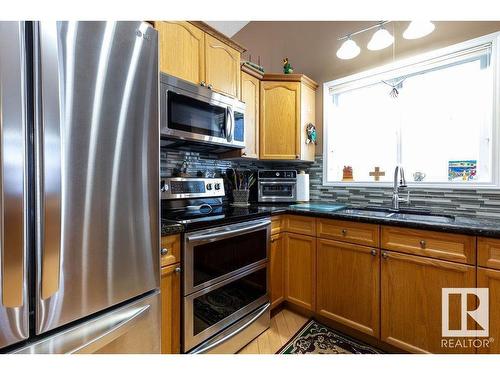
[[260, 74, 317, 161]]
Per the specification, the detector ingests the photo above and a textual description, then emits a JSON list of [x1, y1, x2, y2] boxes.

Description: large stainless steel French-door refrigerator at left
[[0, 22, 160, 353]]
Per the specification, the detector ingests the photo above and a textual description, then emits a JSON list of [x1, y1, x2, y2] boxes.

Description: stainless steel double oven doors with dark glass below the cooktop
[[183, 218, 271, 353]]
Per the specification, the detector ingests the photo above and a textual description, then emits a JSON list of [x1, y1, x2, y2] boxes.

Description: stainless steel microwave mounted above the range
[[160, 73, 245, 148]]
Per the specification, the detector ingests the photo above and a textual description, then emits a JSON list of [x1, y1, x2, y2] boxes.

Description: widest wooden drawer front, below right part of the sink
[[381, 227, 476, 264]]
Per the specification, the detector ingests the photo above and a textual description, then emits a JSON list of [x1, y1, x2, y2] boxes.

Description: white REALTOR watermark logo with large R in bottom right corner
[[441, 288, 493, 348]]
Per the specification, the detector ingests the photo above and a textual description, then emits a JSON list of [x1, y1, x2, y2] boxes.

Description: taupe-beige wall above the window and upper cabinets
[[233, 21, 500, 154]]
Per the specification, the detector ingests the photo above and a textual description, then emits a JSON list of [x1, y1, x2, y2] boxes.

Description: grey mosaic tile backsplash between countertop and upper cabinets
[[161, 149, 500, 220]]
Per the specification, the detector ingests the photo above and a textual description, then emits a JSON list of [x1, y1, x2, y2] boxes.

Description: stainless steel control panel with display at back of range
[[160, 177, 225, 199]]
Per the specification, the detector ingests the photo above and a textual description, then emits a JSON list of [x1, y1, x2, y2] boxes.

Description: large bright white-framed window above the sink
[[323, 33, 500, 188]]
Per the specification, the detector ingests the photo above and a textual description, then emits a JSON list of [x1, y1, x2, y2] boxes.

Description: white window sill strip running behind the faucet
[[323, 181, 500, 194]]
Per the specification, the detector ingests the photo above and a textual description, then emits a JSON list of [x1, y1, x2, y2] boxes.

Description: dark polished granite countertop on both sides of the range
[[162, 202, 500, 238]]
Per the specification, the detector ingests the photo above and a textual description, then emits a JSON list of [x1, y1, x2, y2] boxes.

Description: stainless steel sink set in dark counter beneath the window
[[341, 206, 455, 223]]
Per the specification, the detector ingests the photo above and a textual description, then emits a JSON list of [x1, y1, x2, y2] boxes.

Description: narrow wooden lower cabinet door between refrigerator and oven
[[161, 264, 181, 354]]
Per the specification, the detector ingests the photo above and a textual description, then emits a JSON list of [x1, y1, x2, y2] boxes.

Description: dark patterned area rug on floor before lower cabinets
[[276, 319, 383, 354]]
